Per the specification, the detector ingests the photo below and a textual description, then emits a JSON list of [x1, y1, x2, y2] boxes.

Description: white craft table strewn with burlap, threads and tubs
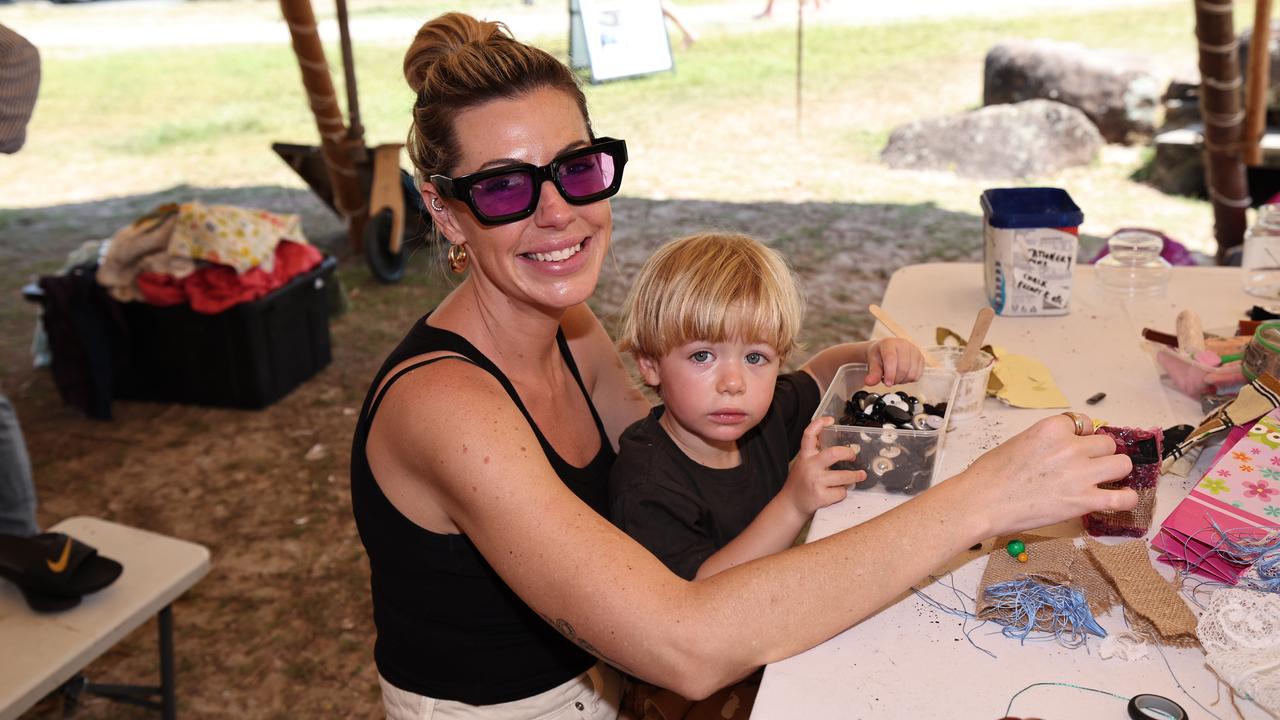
[[751, 263, 1266, 720]]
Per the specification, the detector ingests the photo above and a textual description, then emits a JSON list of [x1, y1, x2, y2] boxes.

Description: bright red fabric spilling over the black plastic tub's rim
[[138, 240, 324, 315]]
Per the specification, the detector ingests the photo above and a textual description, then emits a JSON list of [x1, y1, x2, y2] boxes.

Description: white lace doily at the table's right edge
[[1196, 588, 1280, 716]]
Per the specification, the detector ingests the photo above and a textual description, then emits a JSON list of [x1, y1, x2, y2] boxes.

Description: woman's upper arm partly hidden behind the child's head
[[561, 304, 649, 450]]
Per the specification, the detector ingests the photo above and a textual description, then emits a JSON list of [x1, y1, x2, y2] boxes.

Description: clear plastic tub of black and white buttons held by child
[[813, 363, 959, 495]]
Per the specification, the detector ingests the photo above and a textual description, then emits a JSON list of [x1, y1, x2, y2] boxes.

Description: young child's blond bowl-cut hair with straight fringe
[[618, 232, 804, 360]]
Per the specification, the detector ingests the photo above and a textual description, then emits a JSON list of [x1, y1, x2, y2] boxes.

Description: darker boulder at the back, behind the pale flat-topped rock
[[982, 40, 1162, 142]]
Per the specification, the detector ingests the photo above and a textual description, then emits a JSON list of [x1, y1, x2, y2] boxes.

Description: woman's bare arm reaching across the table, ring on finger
[[370, 363, 1137, 698]]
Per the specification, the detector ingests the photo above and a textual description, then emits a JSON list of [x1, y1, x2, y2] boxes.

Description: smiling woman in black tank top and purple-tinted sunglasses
[[352, 14, 1137, 717]]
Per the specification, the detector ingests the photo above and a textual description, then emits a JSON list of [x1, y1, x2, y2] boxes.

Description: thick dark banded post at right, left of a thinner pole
[[1194, 0, 1249, 263]]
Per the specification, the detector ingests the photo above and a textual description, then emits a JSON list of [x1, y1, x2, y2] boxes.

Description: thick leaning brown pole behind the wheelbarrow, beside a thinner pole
[[280, 0, 369, 252]]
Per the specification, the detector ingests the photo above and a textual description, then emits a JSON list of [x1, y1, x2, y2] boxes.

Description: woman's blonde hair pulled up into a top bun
[[404, 13, 591, 183]]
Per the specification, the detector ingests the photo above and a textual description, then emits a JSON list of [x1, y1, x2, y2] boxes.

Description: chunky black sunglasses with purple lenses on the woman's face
[[431, 137, 627, 225]]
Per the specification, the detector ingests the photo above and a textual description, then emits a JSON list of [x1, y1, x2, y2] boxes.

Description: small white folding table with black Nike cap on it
[[0, 518, 209, 720]]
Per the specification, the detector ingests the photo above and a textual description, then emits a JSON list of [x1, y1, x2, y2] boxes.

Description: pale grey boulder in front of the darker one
[[881, 100, 1103, 178]]
